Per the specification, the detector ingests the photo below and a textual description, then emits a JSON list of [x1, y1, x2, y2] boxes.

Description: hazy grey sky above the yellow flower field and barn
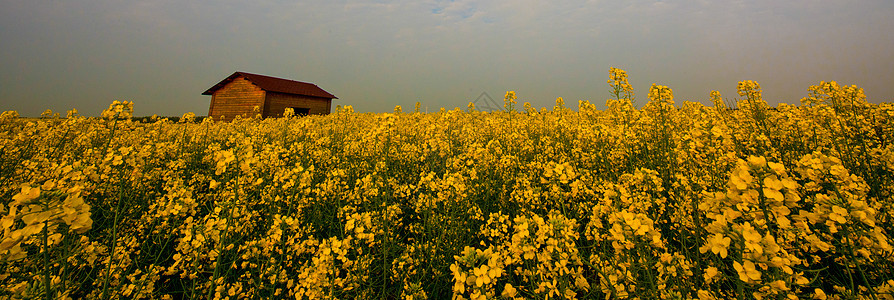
[[0, 0, 894, 116]]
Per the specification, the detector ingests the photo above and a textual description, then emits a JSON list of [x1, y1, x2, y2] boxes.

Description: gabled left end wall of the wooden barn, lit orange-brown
[[208, 76, 266, 121]]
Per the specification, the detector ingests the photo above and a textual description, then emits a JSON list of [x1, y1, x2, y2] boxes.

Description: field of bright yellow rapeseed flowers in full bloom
[[0, 69, 894, 299]]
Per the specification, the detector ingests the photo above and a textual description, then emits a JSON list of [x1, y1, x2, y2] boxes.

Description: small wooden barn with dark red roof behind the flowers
[[202, 72, 338, 121]]
